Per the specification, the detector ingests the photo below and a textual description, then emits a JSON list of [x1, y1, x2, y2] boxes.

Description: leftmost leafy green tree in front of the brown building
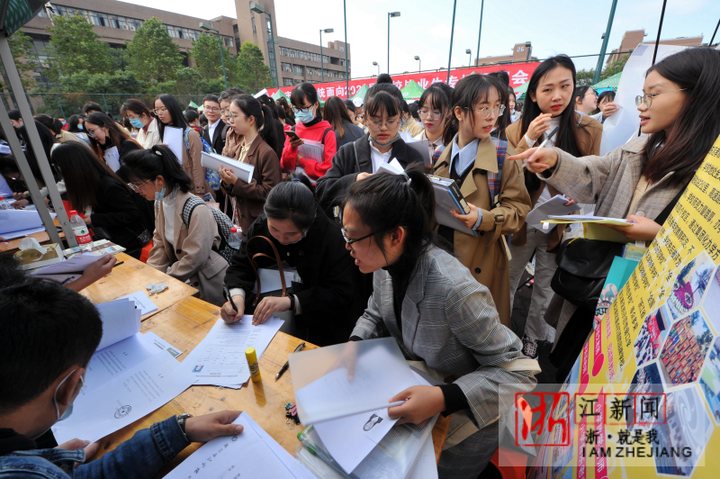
[[47, 15, 112, 81]]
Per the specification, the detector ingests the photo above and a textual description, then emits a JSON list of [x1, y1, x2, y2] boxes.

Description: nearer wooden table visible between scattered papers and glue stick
[[91, 298, 449, 477]]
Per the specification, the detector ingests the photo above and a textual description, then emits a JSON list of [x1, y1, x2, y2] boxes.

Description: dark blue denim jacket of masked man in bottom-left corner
[[0, 417, 190, 479]]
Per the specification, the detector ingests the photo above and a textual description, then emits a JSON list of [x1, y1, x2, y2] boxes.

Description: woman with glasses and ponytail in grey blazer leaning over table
[[342, 166, 538, 479]]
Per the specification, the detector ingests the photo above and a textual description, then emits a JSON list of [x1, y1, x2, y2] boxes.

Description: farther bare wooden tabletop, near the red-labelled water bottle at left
[[81, 253, 204, 320]]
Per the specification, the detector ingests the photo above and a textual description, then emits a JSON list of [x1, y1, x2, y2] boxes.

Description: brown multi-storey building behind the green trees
[[22, 0, 350, 86]]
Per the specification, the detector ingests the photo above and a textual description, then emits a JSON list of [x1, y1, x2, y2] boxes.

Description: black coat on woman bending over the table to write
[[225, 208, 360, 346]]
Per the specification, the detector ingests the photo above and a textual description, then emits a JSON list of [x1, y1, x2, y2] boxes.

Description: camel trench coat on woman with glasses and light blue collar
[[435, 138, 530, 327]]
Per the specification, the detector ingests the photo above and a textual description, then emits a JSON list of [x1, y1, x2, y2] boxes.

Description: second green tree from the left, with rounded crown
[[126, 17, 183, 84]]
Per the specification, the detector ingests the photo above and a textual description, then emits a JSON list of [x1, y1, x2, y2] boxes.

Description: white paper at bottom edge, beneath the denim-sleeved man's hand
[[165, 412, 315, 479]]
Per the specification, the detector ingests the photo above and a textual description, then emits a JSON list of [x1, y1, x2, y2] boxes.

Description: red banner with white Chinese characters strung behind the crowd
[[267, 62, 540, 100]]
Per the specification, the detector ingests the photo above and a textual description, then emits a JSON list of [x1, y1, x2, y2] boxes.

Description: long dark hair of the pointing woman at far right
[[643, 47, 720, 184]]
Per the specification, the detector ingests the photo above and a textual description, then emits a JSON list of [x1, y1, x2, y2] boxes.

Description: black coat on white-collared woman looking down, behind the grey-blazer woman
[[316, 133, 423, 218]]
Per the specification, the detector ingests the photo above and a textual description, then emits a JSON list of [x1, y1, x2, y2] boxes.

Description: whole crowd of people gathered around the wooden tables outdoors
[[0, 48, 720, 478]]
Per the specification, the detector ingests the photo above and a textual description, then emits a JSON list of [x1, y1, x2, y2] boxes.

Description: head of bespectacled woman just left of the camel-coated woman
[[413, 83, 453, 165]]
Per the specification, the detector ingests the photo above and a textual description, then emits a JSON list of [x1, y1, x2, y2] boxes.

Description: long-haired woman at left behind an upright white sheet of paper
[[153, 95, 214, 198]]
